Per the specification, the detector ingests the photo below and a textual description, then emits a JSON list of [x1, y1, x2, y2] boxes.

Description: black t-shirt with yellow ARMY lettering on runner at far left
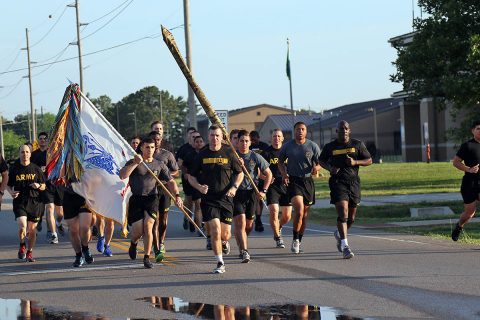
[[8, 162, 45, 198]]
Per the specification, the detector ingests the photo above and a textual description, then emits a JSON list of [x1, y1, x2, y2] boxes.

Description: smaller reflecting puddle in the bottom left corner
[[0, 299, 116, 320]]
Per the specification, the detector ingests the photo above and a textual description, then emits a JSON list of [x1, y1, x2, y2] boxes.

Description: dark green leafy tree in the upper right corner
[[391, 0, 480, 141]]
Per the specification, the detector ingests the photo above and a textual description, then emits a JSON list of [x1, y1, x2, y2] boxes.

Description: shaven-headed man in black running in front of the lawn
[[320, 121, 372, 259]]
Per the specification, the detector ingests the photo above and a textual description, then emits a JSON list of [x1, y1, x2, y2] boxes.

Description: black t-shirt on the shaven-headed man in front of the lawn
[[320, 139, 371, 179]]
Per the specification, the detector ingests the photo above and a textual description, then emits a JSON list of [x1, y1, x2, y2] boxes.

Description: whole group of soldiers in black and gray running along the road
[[0, 121, 480, 273]]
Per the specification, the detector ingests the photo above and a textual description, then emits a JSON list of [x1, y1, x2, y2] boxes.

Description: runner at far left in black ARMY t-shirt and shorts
[[7, 144, 46, 262]]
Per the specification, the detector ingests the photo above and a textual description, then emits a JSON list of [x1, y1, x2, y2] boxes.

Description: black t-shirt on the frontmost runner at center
[[190, 145, 242, 196]]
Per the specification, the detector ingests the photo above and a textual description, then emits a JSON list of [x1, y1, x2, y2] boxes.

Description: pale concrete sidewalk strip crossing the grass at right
[[312, 192, 462, 208]]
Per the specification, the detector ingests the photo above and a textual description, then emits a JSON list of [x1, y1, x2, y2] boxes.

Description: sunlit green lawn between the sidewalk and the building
[[315, 162, 463, 198]]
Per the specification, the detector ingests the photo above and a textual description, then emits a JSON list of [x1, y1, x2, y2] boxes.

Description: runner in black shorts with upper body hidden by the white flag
[[63, 185, 95, 268]]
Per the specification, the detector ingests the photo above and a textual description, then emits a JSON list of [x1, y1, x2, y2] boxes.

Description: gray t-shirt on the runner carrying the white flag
[[125, 159, 172, 196]]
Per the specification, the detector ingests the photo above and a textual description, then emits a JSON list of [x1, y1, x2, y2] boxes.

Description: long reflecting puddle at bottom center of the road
[[137, 296, 361, 320]]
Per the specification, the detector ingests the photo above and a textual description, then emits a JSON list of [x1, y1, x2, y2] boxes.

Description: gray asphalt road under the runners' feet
[[0, 198, 480, 319]]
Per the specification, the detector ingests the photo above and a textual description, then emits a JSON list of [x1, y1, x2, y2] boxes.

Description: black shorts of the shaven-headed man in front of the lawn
[[328, 177, 361, 208]]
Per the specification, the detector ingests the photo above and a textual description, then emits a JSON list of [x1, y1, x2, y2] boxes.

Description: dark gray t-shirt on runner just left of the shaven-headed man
[[279, 139, 320, 178]]
